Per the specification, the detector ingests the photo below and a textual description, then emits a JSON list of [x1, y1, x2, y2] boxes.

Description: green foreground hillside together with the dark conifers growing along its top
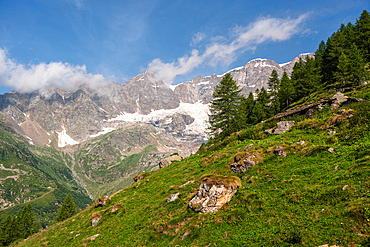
[[11, 10, 370, 246]]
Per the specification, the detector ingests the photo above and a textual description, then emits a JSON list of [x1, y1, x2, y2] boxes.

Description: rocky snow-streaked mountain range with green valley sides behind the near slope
[[0, 53, 313, 227]]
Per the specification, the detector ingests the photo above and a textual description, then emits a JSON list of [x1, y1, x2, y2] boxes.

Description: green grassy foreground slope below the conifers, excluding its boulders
[[17, 85, 370, 246]]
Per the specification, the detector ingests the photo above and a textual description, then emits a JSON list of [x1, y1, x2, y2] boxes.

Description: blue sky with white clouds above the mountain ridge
[[0, 0, 370, 93]]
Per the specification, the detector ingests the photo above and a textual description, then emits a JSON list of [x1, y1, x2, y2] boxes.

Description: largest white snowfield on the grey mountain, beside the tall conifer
[[108, 101, 209, 134]]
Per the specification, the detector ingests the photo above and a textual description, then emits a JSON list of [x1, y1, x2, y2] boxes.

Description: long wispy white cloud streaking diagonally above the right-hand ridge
[[148, 14, 308, 84]]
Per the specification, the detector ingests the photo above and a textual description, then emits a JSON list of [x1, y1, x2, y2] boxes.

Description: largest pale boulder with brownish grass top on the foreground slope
[[189, 174, 241, 214]]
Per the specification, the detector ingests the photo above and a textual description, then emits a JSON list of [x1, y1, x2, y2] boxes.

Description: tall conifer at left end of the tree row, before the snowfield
[[209, 73, 242, 140]]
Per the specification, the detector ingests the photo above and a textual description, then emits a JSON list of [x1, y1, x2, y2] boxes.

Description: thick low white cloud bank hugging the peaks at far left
[[0, 48, 107, 93]]
